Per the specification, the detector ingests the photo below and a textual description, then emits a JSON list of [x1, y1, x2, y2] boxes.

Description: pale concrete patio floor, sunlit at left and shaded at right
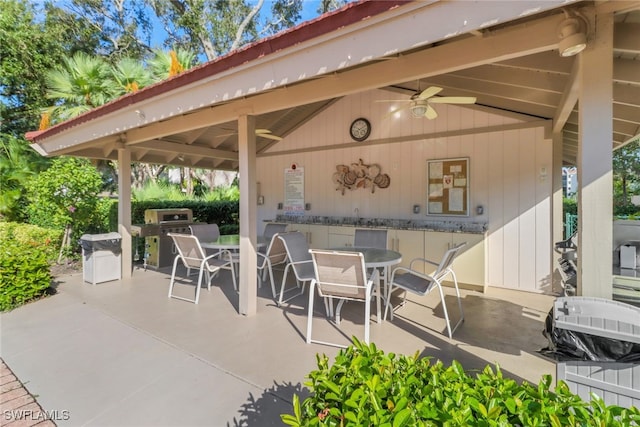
[[0, 268, 555, 426]]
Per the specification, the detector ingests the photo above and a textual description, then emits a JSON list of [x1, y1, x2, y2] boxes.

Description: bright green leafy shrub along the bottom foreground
[[281, 338, 640, 427]]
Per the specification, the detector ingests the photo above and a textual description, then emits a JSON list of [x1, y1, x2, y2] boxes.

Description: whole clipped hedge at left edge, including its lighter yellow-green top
[[0, 223, 56, 311]]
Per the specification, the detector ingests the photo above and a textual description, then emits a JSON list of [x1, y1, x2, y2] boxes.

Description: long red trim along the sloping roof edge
[[25, 0, 411, 141]]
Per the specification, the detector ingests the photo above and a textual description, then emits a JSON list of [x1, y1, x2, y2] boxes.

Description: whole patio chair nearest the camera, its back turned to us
[[307, 249, 380, 347]]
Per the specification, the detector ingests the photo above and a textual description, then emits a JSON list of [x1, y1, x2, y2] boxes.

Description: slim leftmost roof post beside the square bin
[[118, 148, 133, 279]]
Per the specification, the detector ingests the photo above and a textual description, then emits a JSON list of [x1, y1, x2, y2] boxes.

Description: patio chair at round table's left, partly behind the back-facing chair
[[278, 231, 316, 306]]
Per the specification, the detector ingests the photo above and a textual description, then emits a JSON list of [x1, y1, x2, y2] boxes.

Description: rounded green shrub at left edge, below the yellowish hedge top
[[0, 239, 51, 311]]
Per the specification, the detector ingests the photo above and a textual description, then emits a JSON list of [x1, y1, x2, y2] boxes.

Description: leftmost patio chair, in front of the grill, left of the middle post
[[167, 233, 238, 304]]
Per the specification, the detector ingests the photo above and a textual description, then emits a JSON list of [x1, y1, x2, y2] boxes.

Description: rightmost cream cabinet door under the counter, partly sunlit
[[452, 233, 485, 286]]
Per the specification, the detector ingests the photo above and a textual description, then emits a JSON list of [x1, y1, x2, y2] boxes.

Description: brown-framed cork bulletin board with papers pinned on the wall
[[427, 157, 469, 216]]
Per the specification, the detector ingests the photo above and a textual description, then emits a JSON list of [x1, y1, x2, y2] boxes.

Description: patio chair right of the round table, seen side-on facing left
[[384, 243, 466, 338]]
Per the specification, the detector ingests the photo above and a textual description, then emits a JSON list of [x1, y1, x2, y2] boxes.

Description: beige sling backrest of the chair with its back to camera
[[309, 249, 367, 300]]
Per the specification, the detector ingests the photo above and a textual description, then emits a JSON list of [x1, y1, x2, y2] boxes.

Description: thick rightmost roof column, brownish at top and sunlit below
[[577, 13, 613, 299]]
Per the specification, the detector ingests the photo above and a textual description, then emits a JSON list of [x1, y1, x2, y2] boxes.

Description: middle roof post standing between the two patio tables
[[238, 114, 258, 316]]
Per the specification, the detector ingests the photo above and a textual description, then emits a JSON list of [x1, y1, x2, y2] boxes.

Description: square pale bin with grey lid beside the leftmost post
[[80, 232, 122, 285]]
